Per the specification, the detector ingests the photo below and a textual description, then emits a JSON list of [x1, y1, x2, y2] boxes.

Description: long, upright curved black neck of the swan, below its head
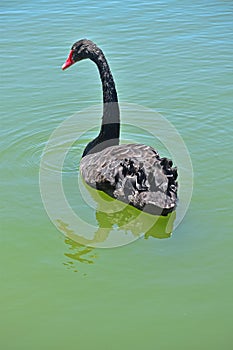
[[82, 47, 120, 157]]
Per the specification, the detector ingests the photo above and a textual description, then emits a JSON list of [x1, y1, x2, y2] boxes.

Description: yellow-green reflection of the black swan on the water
[[57, 186, 176, 268]]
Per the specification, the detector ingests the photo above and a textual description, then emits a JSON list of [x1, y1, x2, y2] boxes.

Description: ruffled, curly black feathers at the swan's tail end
[[113, 157, 178, 215]]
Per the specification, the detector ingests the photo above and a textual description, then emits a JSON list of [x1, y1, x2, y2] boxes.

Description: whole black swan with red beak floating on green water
[[62, 39, 178, 215]]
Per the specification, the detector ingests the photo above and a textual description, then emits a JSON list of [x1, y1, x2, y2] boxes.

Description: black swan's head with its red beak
[[62, 39, 98, 70]]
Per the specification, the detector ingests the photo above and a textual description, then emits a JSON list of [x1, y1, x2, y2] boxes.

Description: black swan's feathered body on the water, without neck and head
[[80, 144, 178, 215]]
